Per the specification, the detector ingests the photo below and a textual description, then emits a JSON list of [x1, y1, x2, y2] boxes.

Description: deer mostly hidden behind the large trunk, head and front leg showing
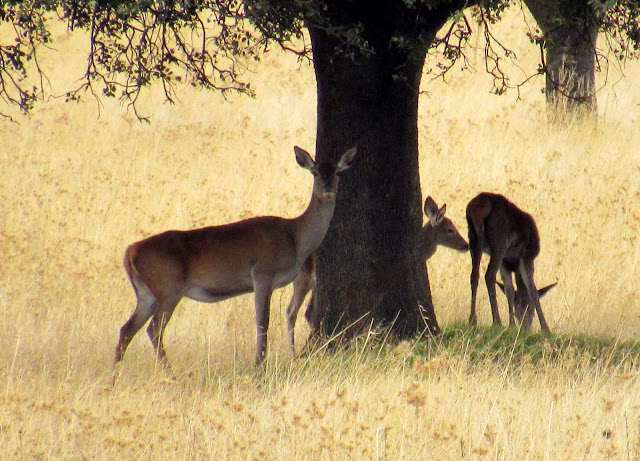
[[287, 197, 469, 356]]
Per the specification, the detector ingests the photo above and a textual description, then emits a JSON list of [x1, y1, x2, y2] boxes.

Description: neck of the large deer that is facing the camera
[[293, 194, 336, 261]]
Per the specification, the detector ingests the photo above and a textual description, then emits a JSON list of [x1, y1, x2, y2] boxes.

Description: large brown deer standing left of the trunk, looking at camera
[[115, 147, 356, 368]]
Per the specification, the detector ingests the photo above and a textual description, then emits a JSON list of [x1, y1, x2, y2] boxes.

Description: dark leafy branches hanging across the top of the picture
[[0, 0, 640, 117]]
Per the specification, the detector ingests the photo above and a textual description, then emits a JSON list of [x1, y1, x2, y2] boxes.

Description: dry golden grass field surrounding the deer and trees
[[0, 9, 640, 460]]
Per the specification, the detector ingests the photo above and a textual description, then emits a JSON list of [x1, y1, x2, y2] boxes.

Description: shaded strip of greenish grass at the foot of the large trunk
[[234, 323, 640, 392]]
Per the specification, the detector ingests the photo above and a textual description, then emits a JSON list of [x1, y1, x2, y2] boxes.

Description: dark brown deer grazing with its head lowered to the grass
[[467, 192, 549, 331]]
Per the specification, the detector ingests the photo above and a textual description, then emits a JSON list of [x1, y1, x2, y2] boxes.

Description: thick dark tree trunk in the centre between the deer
[[309, 2, 450, 338]]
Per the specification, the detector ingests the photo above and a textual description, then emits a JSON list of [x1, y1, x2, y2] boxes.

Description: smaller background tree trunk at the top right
[[525, 0, 600, 118]]
